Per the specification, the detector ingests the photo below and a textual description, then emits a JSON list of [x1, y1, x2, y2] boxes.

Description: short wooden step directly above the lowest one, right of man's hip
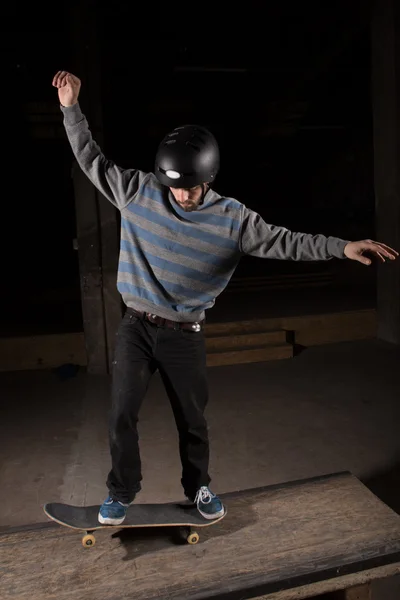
[[206, 329, 287, 352]]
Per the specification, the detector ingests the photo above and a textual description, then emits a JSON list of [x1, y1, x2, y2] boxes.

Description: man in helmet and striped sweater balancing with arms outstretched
[[53, 71, 398, 525]]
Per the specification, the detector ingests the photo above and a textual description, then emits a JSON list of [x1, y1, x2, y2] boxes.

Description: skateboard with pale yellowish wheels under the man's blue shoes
[[43, 502, 227, 548]]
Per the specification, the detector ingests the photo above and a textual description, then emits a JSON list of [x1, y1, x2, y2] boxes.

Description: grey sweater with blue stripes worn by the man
[[61, 104, 347, 322]]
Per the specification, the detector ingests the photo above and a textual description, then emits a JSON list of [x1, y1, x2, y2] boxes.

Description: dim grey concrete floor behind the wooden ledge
[[0, 340, 400, 600]]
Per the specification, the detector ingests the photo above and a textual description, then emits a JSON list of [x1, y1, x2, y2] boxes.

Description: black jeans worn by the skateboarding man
[[107, 310, 211, 503]]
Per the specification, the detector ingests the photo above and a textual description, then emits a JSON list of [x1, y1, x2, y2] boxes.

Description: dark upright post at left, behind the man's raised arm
[[69, 0, 122, 374]]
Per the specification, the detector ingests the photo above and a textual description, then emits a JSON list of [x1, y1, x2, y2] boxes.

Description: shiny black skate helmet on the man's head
[[155, 125, 219, 188]]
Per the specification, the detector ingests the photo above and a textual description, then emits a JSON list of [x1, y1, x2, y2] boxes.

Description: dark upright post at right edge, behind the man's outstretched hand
[[371, 0, 400, 344]]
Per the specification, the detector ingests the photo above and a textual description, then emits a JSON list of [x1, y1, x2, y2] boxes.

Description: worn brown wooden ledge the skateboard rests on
[[0, 473, 400, 600]]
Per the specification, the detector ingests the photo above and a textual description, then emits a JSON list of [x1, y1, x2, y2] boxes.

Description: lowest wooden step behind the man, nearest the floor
[[207, 344, 293, 367]]
